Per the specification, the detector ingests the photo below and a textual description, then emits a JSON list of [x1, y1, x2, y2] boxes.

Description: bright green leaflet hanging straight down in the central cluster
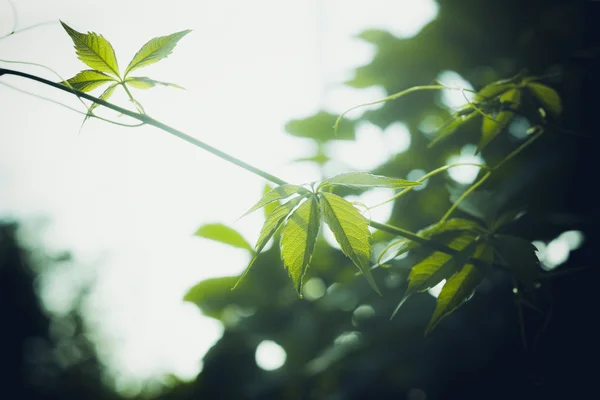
[[281, 196, 321, 296]]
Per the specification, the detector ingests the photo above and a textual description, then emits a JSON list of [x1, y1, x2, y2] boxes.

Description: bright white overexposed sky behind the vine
[[0, 0, 437, 392]]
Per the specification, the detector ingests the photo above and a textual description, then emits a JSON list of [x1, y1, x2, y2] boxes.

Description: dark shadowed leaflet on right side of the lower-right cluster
[[492, 235, 540, 289]]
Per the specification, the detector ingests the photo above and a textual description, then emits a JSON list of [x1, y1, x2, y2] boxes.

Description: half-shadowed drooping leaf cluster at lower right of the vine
[[386, 211, 541, 334]]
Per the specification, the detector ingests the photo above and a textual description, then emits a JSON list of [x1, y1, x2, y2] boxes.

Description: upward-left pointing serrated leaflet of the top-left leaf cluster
[[60, 21, 119, 77]]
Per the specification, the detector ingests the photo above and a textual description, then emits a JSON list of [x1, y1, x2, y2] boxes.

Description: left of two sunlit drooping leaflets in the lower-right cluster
[[392, 235, 476, 318]]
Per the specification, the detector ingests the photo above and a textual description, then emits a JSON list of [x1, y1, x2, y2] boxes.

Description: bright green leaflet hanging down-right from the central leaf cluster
[[319, 192, 381, 295]]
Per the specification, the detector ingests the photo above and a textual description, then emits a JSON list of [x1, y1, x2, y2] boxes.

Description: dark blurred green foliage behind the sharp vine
[[0, 0, 600, 400]]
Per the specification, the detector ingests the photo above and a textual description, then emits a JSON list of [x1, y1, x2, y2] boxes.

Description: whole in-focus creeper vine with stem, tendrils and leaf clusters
[[0, 21, 562, 333]]
